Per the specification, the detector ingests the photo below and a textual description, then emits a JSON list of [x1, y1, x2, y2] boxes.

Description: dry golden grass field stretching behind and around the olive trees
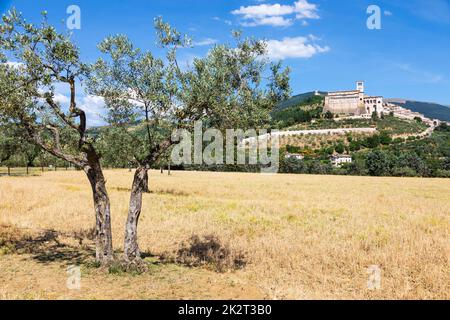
[[0, 170, 450, 299]]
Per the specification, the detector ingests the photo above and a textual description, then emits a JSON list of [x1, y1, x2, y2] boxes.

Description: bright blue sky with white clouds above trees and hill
[[0, 0, 450, 123]]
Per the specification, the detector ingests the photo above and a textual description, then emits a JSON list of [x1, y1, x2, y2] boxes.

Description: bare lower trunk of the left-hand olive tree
[[84, 162, 114, 265]]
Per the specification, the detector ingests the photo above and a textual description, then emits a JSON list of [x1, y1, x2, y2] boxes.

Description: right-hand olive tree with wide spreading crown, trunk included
[[89, 18, 290, 263]]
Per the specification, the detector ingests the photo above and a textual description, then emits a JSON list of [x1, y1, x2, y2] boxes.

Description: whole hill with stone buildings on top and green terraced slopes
[[247, 81, 449, 176]]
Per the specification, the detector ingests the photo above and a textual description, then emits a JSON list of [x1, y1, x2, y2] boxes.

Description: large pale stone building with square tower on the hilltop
[[324, 81, 384, 117]]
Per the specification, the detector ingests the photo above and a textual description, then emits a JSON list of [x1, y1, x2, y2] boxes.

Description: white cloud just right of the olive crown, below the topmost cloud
[[267, 35, 330, 60]]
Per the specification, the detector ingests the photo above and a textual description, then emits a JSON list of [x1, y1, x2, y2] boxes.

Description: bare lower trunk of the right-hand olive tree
[[124, 166, 148, 263]]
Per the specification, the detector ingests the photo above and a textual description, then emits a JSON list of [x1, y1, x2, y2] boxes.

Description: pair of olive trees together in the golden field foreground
[[0, 10, 290, 264]]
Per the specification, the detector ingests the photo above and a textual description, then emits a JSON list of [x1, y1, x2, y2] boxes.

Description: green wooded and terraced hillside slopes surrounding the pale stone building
[[272, 93, 450, 177]]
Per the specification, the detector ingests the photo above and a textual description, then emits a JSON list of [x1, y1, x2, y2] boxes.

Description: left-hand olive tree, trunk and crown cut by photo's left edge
[[0, 9, 113, 264]]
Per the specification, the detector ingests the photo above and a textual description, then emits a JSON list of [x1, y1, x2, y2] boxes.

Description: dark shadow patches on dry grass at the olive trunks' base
[[0, 225, 247, 274]]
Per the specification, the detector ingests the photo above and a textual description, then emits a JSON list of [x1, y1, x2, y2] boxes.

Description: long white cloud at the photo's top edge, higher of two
[[231, 0, 320, 27]]
